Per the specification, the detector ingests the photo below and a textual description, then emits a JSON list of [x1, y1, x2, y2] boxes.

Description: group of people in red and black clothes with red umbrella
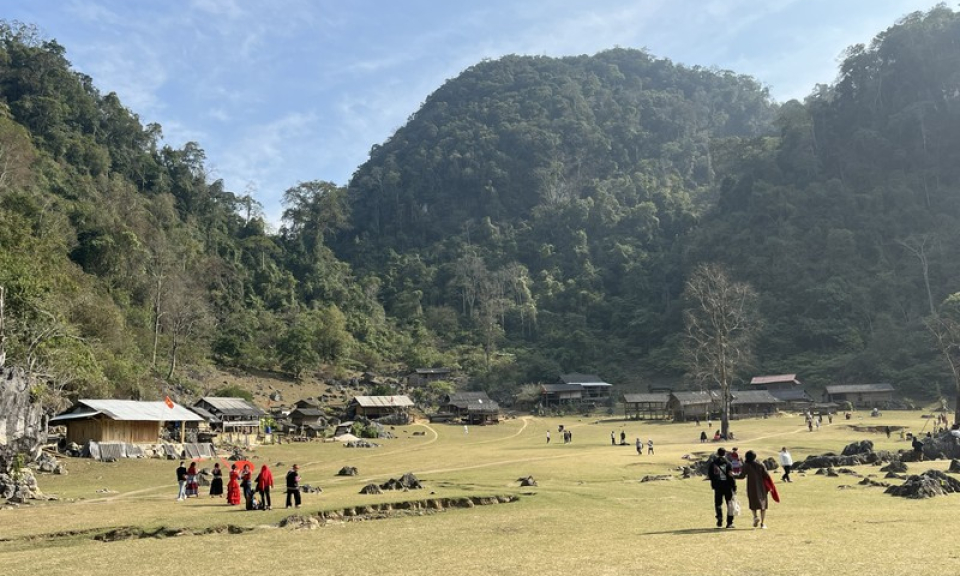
[[177, 461, 300, 510]]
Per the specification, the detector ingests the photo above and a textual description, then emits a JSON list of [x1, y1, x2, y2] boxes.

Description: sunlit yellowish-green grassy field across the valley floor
[[0, 412, 960, 576]]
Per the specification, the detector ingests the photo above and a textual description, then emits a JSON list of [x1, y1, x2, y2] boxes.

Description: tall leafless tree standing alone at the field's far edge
[[684, 264, 761, 437]]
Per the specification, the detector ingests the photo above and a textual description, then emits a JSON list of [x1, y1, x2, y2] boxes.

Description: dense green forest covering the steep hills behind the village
[[0, 6, 960, 410]]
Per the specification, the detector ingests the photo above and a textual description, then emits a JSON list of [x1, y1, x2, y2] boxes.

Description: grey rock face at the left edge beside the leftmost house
[[0, 368, 44, 472]]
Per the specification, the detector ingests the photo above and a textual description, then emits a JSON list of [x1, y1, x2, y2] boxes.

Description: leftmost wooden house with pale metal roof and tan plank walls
[[50, 400, 201, 445]]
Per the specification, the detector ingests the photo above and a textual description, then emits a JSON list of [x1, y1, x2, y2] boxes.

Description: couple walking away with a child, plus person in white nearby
[[707, 447, 780, 529]]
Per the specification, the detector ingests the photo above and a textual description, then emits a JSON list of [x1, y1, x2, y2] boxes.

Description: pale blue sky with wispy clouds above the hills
[[0, 0, 935, 226]]
